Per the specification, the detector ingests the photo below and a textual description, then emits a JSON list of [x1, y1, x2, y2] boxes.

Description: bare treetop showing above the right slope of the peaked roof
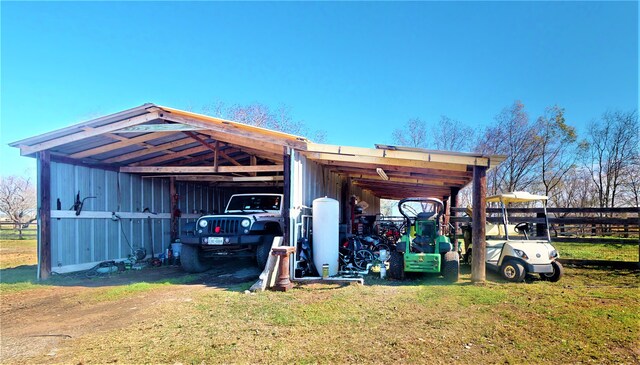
[[201, 101, 327, 143]]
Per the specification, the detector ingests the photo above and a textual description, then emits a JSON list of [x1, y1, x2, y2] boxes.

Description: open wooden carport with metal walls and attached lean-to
[[10, 104, 504, 280]]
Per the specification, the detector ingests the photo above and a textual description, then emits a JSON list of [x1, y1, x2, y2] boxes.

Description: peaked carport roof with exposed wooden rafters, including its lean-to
[[10, 103, 505, 199]]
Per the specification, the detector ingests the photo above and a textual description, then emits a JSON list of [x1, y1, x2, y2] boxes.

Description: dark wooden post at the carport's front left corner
[[38, 150, 51, 280]]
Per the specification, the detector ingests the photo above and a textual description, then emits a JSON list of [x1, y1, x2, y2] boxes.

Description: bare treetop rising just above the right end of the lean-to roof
[[431, 115, 475, 152]]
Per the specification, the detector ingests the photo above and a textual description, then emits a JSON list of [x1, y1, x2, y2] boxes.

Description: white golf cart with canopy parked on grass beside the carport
[[463, 191, 564, 282]]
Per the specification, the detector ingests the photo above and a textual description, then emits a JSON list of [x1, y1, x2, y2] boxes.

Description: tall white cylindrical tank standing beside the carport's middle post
[[313, 197, 340, 276]]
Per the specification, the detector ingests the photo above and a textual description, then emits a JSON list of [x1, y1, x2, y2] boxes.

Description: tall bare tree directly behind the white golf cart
[[475, 101, 541, 194]]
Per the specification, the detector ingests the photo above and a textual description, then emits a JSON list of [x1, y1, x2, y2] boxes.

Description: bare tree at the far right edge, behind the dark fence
[[582, 111, 638, 208]]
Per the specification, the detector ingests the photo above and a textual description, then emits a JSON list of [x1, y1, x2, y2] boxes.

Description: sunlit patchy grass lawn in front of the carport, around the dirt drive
[[0, 237, 640, 364]]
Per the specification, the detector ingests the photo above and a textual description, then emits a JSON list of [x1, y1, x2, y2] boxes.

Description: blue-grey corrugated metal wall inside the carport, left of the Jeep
[[51, 162, 218, 270]]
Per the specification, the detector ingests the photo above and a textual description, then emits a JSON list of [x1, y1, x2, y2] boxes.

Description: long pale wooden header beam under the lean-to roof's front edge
[[305, 152, 467, 171]]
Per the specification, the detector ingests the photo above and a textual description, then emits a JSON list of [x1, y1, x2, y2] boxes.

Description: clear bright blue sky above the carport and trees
[[0, 1, 638, 178]]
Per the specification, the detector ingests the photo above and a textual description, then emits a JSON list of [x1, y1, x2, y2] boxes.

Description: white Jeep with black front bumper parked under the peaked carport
[[180, 194, 284, 272]]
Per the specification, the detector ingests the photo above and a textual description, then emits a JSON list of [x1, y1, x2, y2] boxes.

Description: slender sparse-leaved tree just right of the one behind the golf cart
[[538, 105, 577, 199]]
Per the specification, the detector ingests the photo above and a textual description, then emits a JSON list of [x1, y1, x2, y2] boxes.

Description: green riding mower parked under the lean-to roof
[[389, 197, 460, 282]]
